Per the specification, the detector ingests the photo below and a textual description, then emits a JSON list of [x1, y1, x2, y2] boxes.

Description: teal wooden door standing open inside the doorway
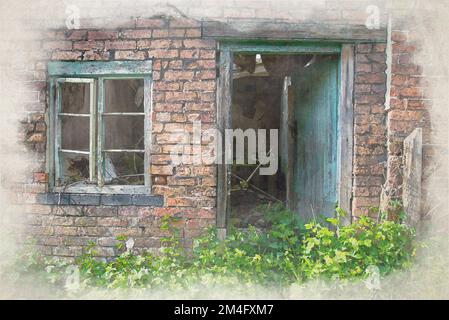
[[292, 56, 339, 220]]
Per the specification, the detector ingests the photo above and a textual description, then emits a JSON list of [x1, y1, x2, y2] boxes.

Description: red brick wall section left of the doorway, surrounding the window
[[18, 18, 216, 256]]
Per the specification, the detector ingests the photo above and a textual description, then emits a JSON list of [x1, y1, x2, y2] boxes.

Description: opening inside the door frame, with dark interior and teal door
[[230, 53, 339, 227]]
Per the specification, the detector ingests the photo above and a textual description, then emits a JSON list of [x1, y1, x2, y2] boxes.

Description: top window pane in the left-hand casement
[[61, 82, 90, 114]]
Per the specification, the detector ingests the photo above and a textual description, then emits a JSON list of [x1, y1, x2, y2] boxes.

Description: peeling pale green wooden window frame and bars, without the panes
[[47, 60, 152, 194]]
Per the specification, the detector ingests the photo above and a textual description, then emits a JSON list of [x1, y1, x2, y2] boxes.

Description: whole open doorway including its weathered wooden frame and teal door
[[217, 43, 353, 232]]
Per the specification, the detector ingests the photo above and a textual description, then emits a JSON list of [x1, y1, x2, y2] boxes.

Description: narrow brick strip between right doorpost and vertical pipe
[[352, 43, 387, 216]]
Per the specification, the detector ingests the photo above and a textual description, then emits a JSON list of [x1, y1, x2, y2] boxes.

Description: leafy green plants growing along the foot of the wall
[[9, 205, 415, 289]]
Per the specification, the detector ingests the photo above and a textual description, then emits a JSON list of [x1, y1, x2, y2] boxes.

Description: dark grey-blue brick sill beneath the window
[[37, 192, 164, 207]]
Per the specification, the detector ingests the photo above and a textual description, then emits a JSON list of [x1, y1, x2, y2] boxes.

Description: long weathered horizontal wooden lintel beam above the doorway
[[202, 20, 387, 42]]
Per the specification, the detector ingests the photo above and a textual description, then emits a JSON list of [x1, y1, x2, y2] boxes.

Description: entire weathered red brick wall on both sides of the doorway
[[9, 1, 430, 256]]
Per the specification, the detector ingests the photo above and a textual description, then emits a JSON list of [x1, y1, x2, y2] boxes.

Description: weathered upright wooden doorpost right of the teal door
[[337, 44, 354, 223]]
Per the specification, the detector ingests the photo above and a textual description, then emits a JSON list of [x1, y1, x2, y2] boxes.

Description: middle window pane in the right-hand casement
[[104, 115, 144, 150]]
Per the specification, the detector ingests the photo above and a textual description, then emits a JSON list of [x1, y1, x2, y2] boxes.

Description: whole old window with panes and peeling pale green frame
[[47, 61, 151, 193]]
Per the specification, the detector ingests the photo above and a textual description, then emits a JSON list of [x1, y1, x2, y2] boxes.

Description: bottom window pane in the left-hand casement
[[59, 152, 89, 186]]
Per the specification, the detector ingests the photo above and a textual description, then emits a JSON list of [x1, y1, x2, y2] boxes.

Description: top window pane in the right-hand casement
[[104, 79, 144, 113]]
